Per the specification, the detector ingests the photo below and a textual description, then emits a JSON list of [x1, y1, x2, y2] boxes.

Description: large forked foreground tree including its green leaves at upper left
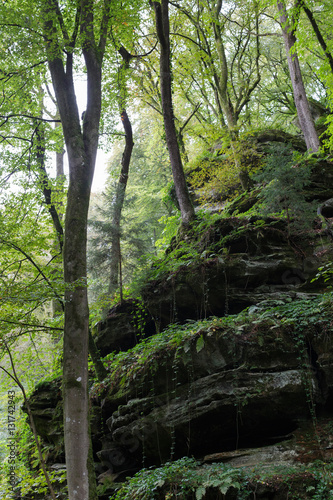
[[1, 0, 115, 500]]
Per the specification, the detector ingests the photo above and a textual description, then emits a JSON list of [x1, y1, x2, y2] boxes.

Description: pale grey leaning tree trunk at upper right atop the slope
[[277, 1, 320, 152]]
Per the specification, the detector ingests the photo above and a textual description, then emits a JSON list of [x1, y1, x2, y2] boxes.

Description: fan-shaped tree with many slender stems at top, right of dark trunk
[[172, 0, 261, 130]]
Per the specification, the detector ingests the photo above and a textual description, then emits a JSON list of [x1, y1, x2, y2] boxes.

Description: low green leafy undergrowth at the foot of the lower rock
[[110, 458, 333, 500]]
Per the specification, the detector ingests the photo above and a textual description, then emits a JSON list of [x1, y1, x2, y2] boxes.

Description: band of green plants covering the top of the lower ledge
[[91, 293, 333, 400]]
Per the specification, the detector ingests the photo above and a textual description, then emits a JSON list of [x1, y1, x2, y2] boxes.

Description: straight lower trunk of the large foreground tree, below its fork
[[63, 151, 94, 500]]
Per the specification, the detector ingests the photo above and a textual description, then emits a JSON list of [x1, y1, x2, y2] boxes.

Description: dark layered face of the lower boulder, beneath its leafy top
[[99, 321, 333, 469]]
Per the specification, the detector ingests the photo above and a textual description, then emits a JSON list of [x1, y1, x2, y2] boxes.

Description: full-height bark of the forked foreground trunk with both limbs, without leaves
[[43, 0, 111, 500]]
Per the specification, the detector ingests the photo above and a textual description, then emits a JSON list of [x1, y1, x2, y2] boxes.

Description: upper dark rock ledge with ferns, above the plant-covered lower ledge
[[143, 217, 333, 330]]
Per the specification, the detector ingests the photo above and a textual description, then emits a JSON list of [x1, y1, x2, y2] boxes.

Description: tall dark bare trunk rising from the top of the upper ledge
[[150, 0, 195, 224]]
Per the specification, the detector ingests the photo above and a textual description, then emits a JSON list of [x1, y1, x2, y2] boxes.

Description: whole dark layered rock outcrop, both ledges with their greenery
[[24, 160, 333, 496]]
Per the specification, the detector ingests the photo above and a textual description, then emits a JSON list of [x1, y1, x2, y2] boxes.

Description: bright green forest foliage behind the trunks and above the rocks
[[0, 0, 333, 498]]
